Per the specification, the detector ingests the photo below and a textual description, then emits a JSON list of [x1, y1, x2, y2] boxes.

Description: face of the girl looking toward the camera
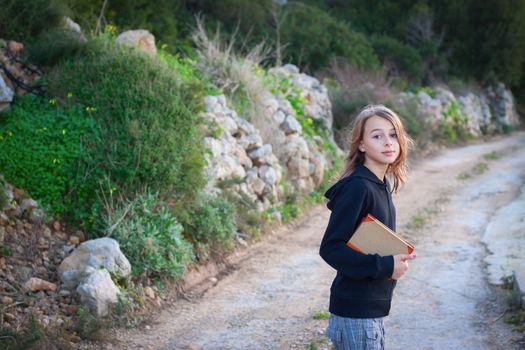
[[359, 115, 399, 167]]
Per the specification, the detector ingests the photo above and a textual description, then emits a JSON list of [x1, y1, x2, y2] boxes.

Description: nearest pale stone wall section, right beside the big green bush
[[204, 95, 282, 210]]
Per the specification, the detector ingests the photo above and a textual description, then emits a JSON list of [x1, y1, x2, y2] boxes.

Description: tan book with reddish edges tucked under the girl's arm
[[346, 214, 414, 256]]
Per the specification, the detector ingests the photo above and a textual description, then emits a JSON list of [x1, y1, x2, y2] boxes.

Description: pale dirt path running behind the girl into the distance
[[108, 133, 525, 350]]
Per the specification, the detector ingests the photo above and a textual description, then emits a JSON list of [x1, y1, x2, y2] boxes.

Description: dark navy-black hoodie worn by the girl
[[319, 165, 396, 318]]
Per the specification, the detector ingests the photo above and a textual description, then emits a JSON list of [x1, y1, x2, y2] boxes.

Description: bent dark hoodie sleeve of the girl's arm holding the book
[[319, 181, 394, 279]]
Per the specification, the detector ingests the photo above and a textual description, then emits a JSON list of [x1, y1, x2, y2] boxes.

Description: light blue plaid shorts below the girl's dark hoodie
[[326, 314, 385, 350]]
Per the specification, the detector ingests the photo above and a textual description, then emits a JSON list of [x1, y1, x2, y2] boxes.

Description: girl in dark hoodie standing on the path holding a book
[[320, 105, 415, 350]]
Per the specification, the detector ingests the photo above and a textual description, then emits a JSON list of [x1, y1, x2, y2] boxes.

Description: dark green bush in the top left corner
[[0, 0, 67, 41]]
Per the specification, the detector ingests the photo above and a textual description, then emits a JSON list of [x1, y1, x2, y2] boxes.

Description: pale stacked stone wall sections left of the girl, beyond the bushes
[[204, 65, 337, 210]]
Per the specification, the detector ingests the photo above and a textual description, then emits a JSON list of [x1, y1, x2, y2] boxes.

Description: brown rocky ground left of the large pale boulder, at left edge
[[0, 187, 85, 341]]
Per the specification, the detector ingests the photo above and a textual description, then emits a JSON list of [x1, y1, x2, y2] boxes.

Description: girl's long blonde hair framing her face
[[341, 105, 413, 192]]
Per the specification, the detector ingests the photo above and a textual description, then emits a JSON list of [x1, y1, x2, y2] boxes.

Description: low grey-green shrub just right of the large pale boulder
[[104, 194, 192, 279]]
